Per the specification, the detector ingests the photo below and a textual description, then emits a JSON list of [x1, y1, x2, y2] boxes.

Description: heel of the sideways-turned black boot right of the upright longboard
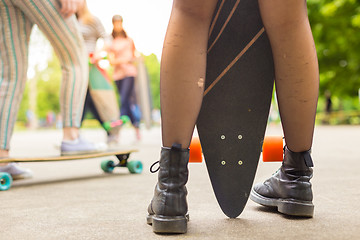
[[278, 201, 314, 217]]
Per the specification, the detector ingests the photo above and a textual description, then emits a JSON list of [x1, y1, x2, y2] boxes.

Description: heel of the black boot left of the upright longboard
[[152, 216, 187, 233]]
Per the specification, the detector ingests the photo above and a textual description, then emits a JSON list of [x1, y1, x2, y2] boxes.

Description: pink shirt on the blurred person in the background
[[109, 37, 137, 81]]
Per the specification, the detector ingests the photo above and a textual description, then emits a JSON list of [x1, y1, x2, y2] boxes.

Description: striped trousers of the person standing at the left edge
[[0, 0, 89, 149]]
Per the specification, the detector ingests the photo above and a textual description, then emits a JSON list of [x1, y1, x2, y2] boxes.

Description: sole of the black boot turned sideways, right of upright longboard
[[250, 189, 314, 217]]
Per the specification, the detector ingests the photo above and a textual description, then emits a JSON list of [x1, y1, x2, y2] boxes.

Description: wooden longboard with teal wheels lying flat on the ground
[[0, 150, 143, 191]]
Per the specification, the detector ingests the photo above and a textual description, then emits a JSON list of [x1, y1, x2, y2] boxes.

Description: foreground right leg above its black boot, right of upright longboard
[[259, 0, 319, 152]]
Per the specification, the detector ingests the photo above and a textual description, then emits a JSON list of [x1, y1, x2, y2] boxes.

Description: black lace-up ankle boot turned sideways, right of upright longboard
[[250, 147, 314, 217]]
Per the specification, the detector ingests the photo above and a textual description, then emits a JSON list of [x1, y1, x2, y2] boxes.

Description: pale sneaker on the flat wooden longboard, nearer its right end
[[61, 138, 107, 156]]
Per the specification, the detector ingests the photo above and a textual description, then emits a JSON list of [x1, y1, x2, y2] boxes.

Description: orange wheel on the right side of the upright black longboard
[[263, 136, 284, 162]]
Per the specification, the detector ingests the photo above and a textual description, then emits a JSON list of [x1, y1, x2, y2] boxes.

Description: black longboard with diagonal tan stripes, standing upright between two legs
[[197, 0, 274, 218]]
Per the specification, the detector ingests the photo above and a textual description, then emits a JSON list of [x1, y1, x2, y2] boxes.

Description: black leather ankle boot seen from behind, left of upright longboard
[[147, 144, 189, 233]]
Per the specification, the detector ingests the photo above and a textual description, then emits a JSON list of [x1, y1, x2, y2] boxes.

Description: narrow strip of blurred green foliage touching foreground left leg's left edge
[[143, 54, 160, 109]]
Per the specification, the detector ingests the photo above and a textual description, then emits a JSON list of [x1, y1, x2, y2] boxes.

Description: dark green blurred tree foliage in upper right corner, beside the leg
[[308, 0, 360, 97]]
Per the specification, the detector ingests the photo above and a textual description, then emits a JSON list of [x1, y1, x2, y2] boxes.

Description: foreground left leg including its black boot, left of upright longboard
[[147, 0, 217, 233]]
